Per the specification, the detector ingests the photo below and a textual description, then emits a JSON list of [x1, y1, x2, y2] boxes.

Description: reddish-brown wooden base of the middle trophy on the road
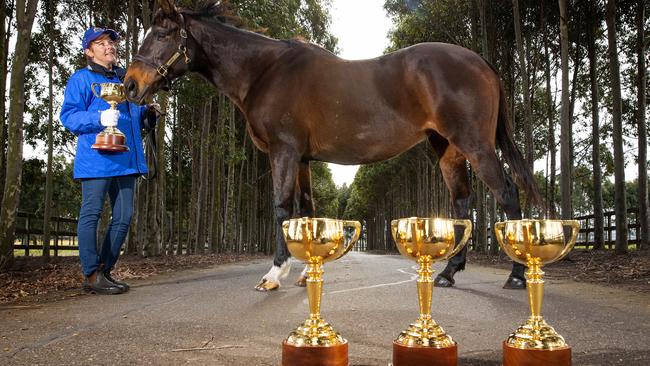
[[393, 342, 458, 366]]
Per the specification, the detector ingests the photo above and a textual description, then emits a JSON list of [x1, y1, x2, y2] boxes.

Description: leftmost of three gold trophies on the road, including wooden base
[[282, 217, 361, 366]]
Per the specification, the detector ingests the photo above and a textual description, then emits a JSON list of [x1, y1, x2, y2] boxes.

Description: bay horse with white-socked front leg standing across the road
[[124, 0, 539, 291]]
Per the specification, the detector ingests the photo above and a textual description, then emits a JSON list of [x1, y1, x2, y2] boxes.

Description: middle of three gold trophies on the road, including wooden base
[[391, 217, 472, 366]]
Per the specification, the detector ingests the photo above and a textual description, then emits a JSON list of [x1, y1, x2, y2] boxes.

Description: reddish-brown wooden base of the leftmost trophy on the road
[[282, 341, 348, 366]]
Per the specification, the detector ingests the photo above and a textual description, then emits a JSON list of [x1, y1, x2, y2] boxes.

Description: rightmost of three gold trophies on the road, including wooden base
[[494, 220, 580, 366]]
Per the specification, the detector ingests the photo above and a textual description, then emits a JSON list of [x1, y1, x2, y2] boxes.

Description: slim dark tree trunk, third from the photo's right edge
[[587, 4, 605, 250]]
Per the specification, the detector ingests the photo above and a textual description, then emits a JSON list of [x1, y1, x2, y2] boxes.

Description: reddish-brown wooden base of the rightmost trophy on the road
[[503, 342, 571, 366]]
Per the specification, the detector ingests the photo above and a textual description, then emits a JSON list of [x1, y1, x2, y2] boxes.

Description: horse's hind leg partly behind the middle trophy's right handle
[[429, 139, 472, 287]]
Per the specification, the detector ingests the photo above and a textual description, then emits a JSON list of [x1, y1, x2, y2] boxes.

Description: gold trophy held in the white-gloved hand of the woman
[[90, 83, 129, 152]]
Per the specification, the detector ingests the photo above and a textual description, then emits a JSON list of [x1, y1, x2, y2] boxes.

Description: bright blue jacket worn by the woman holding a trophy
[[60, 64, 147, 179]]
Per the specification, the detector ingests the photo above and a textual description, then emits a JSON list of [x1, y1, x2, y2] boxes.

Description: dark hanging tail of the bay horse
[[488, 81, 542, 206]]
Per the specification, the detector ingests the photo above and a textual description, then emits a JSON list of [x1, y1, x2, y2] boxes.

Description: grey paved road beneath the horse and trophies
[[0, 253, 650, 366]]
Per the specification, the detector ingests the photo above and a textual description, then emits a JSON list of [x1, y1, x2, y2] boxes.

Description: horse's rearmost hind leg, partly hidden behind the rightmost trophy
[[460, 149, 526, 289]]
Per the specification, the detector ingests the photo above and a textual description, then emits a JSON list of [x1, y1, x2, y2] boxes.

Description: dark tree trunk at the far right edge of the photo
[[636, 0, 650, 249]]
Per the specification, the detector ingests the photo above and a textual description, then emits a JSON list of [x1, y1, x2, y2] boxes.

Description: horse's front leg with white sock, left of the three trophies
[[255, 151, 299, 291]]
